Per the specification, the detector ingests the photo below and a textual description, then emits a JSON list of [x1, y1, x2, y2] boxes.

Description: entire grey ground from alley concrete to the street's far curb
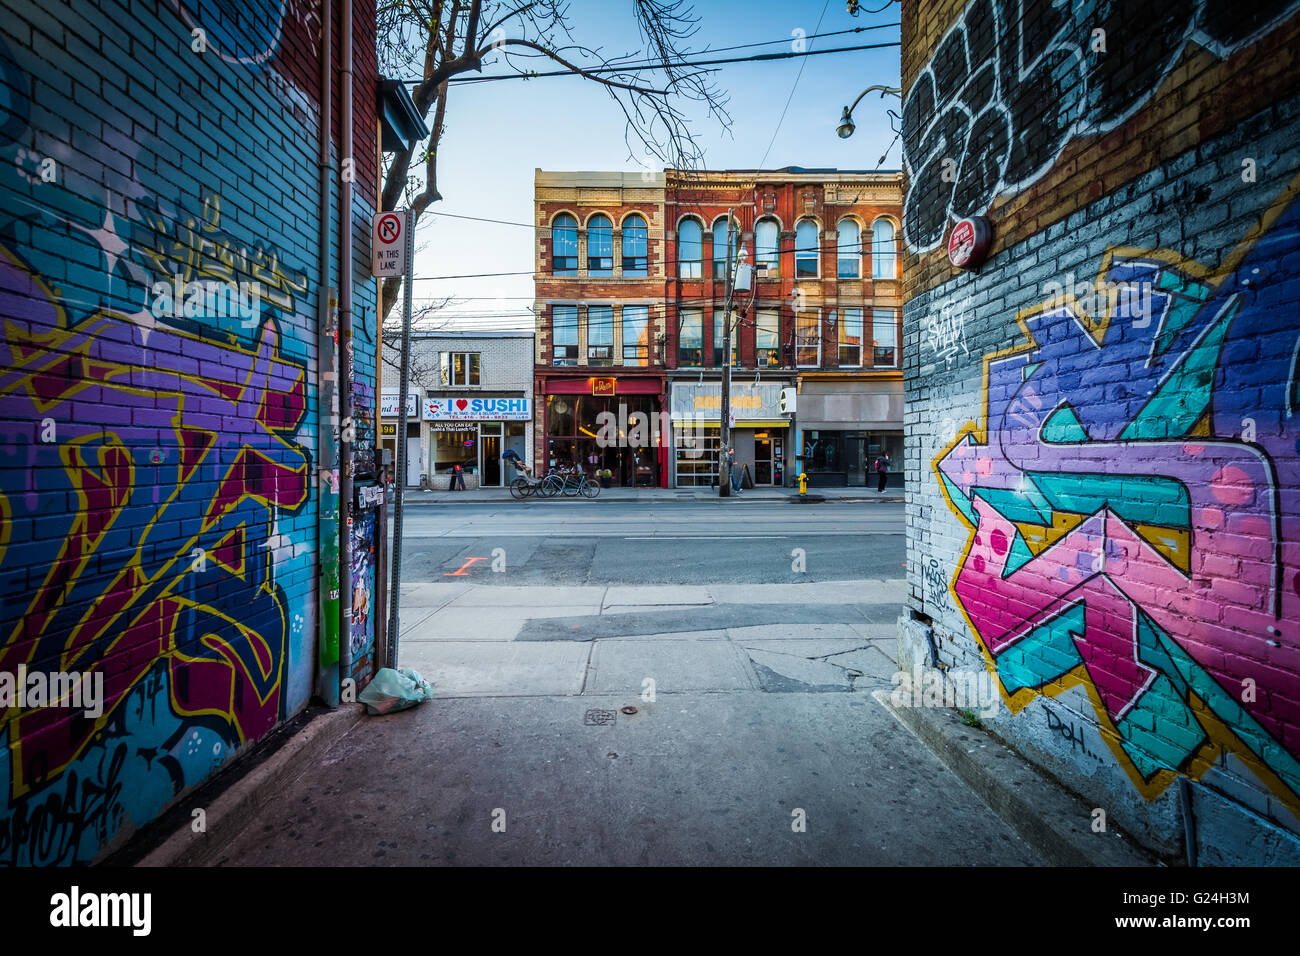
[[208, 503, 1040, 866]]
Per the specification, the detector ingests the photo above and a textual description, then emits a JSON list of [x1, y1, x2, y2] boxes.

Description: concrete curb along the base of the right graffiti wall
[[871, 691, 1158, 866]]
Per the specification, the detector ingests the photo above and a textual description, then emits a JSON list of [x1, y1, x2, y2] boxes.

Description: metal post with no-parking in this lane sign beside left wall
[[371, 209, 415, 667]]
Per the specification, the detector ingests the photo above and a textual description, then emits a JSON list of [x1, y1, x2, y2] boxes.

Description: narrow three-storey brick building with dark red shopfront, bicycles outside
[[533, 169, 671, 488]]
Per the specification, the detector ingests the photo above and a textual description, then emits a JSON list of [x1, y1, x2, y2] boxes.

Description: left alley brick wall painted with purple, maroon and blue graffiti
[[0, 0, 376, 864]]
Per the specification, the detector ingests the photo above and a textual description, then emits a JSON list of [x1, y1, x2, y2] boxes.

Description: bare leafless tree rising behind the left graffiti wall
[[378, 0, 731, 316]]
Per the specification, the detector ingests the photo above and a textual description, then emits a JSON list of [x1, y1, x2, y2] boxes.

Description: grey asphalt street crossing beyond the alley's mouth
[[402, 501, 906, 585]]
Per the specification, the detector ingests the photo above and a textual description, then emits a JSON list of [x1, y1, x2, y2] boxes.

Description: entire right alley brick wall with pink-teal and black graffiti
[[900, 0, 1300, 862]]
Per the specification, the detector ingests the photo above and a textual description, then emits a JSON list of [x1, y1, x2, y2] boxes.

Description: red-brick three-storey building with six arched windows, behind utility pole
[[664, 168, 902, 486]]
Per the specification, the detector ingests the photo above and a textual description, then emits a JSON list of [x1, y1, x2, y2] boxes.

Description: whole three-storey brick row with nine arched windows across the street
[[536, 169, 902, 488]]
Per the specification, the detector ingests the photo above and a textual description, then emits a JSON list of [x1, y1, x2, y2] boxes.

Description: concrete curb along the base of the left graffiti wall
[[135, 704, 364, 866]]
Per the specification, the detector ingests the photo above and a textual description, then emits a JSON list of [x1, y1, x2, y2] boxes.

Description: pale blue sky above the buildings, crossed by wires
[[415, 0, 901, 328]]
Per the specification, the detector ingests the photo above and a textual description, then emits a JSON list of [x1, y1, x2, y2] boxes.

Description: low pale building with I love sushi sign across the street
[[380, 332, 533, 489]]
